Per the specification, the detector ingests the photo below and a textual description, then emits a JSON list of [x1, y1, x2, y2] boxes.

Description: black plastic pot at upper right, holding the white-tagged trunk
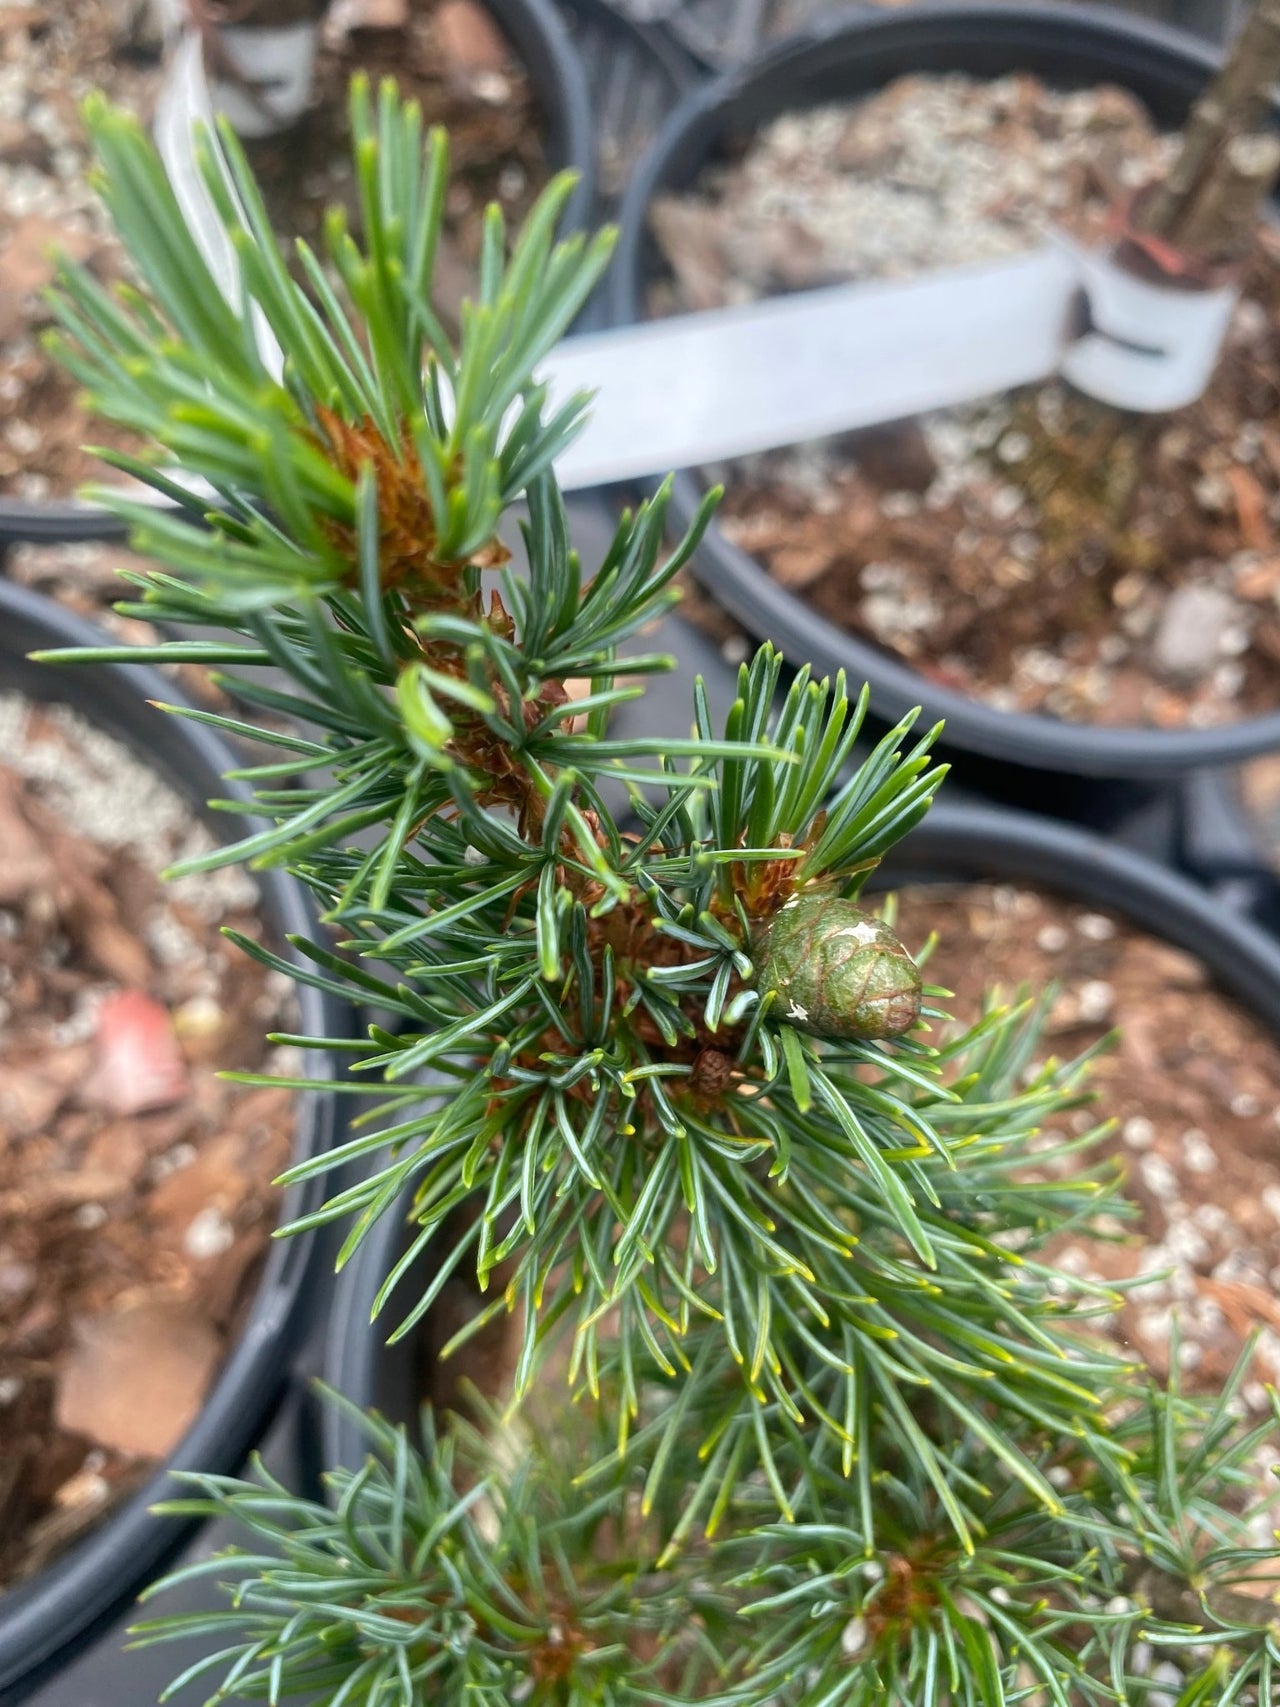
[[609, 3, 1280, 785]]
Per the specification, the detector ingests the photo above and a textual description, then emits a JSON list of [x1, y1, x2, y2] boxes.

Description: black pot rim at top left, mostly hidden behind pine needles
[[0, 0, 596, 548]]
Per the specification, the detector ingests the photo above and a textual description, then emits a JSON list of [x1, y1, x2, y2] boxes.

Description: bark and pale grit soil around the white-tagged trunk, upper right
[[652, 75, 1280, 727]]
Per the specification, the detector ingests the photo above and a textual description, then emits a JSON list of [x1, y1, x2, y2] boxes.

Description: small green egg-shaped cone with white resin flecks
[[754, 894, 920, 1040]]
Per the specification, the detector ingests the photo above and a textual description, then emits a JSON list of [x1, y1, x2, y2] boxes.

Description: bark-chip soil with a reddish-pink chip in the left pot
[[0, 693, 294, 1591]]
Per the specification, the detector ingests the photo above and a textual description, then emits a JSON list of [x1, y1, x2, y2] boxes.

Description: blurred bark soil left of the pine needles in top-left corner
[[0, 0, 160, 500]]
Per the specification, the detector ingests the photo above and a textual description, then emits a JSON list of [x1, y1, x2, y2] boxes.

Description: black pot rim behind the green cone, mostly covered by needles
[[323, 806, 1280, 1468]]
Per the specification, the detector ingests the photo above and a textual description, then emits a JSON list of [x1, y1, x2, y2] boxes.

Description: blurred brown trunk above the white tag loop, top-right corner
[[1137, 0, 1280, 261]]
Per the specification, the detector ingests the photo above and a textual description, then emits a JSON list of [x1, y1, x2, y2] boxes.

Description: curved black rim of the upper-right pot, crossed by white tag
[[608, 0, 1280, 777]]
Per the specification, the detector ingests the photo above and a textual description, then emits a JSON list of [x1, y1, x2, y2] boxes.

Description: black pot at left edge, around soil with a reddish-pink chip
[[0, 580, 352, 1702]]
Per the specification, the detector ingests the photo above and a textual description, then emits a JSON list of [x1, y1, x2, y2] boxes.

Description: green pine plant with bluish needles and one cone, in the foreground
[[45, 84, 1280, 1707]]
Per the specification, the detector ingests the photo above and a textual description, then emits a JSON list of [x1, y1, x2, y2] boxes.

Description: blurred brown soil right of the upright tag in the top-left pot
[[247, 0, 550, 326]]
